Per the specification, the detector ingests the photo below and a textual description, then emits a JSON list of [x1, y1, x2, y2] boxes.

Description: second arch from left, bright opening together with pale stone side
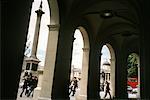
[[69, 27, 89, 100]]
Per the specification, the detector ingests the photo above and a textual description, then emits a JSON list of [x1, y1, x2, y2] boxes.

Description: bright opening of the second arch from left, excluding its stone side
[[69, 29, 83, 98]]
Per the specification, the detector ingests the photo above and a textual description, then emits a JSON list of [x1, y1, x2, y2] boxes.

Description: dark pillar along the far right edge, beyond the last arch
[[139, 0, 150, 99]]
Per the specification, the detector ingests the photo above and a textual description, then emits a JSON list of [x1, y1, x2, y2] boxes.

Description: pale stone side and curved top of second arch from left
[[74, 26, 90, 100]]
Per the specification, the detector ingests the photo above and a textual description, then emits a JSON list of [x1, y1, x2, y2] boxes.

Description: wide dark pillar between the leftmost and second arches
[[52, 25, 74, 100]]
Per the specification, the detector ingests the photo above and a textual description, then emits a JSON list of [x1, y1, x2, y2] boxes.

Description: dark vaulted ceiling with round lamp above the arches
[[58, 0, 140, 45]]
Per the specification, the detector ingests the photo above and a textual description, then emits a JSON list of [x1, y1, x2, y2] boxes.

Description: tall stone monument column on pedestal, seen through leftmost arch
[[24, 1, 44, 76]]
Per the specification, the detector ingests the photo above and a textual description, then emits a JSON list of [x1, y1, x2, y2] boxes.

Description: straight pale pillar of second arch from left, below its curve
[[77, 48, 89, 100]]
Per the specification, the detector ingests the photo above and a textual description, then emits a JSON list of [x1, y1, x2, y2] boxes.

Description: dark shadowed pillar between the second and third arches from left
[[87, 43, 100, 100]]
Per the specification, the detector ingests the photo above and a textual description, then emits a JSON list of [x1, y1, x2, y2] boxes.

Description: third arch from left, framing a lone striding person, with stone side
[[100, 43, 115, 99]]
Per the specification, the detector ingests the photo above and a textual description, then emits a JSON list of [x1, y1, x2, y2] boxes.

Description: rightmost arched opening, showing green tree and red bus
[[127, 53, 140, 98]]
